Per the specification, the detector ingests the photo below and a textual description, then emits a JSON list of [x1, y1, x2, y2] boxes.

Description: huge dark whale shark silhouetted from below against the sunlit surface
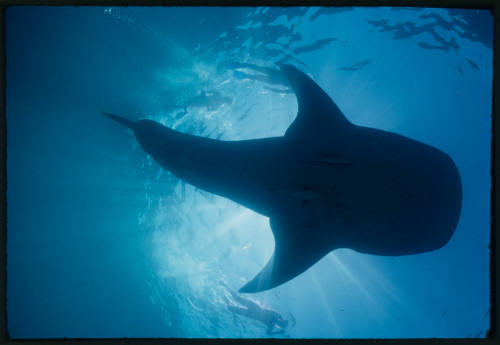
[[103, 65, 462, 293]]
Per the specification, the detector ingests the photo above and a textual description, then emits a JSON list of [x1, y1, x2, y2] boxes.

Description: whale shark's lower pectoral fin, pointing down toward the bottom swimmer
[[239, 218, 328, 293]]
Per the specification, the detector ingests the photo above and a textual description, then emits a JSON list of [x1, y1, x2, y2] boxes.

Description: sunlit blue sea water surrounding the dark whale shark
[[6, 7, 493, 338]]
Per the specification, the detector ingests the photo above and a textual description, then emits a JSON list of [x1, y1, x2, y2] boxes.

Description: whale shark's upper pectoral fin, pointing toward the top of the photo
[[281, 65, 351, 139]]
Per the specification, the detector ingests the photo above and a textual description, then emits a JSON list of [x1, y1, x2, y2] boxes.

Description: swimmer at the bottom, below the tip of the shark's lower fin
[[221, 281, 288, 335]]
